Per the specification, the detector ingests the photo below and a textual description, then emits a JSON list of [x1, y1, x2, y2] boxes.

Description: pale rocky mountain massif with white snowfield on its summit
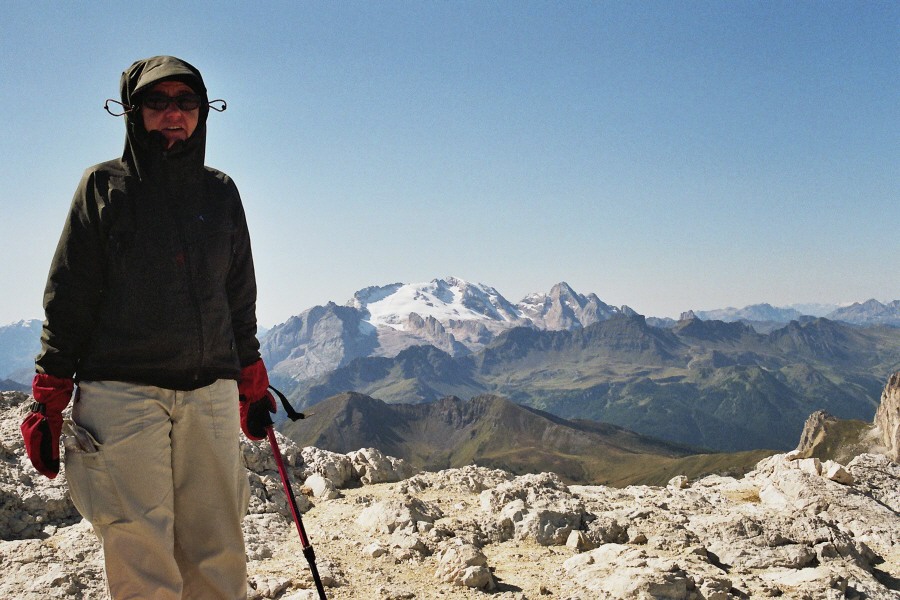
[[262, 277, 630, 381]]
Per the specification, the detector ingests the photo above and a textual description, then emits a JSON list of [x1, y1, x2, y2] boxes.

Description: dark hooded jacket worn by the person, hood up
[[36, 57, 259, 389]]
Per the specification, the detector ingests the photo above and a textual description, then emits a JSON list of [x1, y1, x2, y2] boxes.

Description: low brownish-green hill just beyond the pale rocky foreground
[[282, 393, 771, 486]]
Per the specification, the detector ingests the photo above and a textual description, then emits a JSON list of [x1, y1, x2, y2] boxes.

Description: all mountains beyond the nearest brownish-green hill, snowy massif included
[[0, 277, 900, 451]]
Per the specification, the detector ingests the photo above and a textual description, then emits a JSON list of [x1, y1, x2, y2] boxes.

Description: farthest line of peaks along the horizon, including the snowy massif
[[0, 277, 900, 385]]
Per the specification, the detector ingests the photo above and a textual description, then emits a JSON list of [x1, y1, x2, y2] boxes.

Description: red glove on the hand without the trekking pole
[[19, 373, 75, 479]]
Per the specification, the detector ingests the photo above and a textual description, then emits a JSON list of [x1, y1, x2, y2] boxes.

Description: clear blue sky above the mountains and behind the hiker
[[0, 0, 900, 326]]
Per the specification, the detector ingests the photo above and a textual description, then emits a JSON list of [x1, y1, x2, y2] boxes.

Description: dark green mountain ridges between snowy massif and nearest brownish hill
[[291, 315, 900, 452]]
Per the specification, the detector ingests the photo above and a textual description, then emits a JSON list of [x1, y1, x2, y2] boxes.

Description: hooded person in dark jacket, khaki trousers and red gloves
[[21, 56, 275, 600]]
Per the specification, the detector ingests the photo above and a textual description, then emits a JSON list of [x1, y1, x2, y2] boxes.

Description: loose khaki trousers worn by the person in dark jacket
[[65, 380, 249, 600]]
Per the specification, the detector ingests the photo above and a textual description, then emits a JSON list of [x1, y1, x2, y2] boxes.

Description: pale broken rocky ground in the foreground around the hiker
[[0, 393, 900, 600]]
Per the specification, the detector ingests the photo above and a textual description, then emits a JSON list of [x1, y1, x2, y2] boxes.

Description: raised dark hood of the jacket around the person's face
[[119, 56, 209, 180]]
